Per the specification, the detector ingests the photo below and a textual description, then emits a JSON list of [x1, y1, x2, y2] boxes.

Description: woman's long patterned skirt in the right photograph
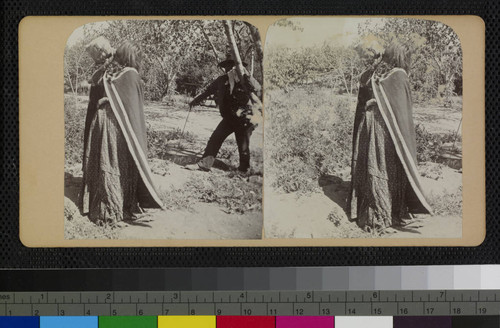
[[350, 106, 411, 231]]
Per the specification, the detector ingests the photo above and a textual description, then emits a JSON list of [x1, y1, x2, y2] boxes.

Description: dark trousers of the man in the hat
[[203, 118, 254, 171]]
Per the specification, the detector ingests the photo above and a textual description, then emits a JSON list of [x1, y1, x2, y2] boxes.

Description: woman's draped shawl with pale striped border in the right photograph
[[371, 69, 432, 213]]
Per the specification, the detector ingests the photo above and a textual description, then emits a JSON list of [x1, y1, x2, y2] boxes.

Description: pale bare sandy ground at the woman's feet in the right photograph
[[264, 163, 462, 238]]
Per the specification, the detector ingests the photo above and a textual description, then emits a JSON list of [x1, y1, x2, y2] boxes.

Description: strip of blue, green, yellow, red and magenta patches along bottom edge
[[0, 316, 500, 328]]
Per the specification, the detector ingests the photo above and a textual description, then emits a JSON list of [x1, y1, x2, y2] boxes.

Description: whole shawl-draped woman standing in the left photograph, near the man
[[80, 40, 162, 225]]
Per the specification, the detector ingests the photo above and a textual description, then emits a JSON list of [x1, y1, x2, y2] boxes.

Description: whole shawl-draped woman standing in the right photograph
[[347, 41, 432, 232]]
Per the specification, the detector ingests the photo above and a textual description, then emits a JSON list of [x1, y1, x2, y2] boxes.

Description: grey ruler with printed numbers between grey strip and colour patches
[[0, 290, 500, 316]]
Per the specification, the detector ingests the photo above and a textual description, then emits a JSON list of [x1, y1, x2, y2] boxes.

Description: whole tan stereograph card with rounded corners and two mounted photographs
[[19, 15, 488, 247]]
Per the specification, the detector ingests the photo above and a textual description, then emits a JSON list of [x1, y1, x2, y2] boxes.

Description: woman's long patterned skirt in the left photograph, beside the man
[[82, 104, 139, 224]]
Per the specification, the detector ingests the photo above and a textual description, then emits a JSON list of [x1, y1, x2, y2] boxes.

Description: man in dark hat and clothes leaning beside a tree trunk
[[186, 55, 262, 173]]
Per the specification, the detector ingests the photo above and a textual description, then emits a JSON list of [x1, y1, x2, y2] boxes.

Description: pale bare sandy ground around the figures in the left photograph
[[65, 103, 262, 239]]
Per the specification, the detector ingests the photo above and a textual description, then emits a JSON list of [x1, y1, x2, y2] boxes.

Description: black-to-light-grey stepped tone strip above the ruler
[[0, 265, 500, 291]]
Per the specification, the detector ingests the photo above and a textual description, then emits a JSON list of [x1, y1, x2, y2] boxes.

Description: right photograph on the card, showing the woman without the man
[[263, 17, 462, 239]]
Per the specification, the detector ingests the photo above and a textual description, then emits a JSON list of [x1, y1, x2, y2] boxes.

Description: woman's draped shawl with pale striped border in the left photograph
[[103, 68, 162, 207]]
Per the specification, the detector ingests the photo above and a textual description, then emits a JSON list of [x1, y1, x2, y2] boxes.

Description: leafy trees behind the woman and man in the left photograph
[[65, 20, 262, 100]]
